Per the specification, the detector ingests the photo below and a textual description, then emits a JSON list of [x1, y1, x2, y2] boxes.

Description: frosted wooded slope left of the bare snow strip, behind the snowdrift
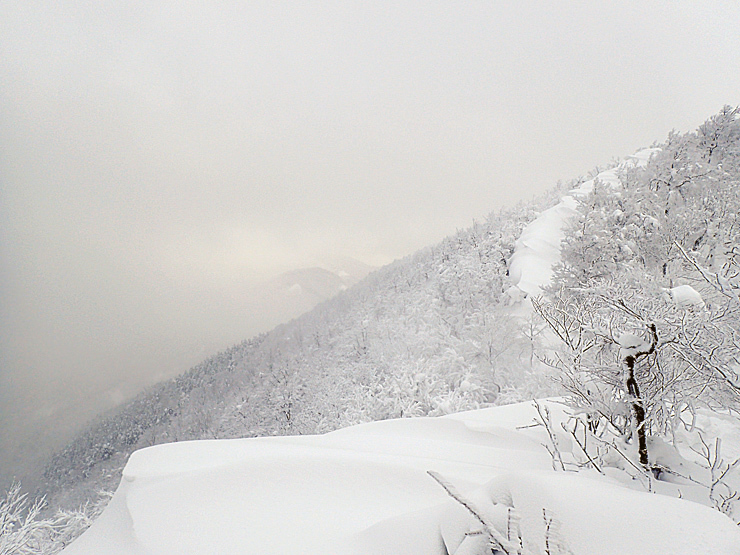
[[44, 180, 558, 505]]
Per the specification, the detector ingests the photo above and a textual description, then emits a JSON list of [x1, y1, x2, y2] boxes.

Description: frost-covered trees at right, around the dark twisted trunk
[[535, 109, 740, 472]]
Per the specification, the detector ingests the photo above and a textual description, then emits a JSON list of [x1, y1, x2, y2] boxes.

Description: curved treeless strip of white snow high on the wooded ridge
[[507, 148, 660, 302]]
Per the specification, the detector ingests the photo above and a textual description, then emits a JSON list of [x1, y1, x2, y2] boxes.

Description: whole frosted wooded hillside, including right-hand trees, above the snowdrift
[[4, 107, 740, 555]]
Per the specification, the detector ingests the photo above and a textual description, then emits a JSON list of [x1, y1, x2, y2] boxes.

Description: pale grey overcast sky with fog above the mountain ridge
[[0, 0, 740, 482]]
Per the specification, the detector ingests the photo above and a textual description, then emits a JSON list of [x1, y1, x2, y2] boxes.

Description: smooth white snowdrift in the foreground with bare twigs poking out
[[63, 401, 740, 555]]
